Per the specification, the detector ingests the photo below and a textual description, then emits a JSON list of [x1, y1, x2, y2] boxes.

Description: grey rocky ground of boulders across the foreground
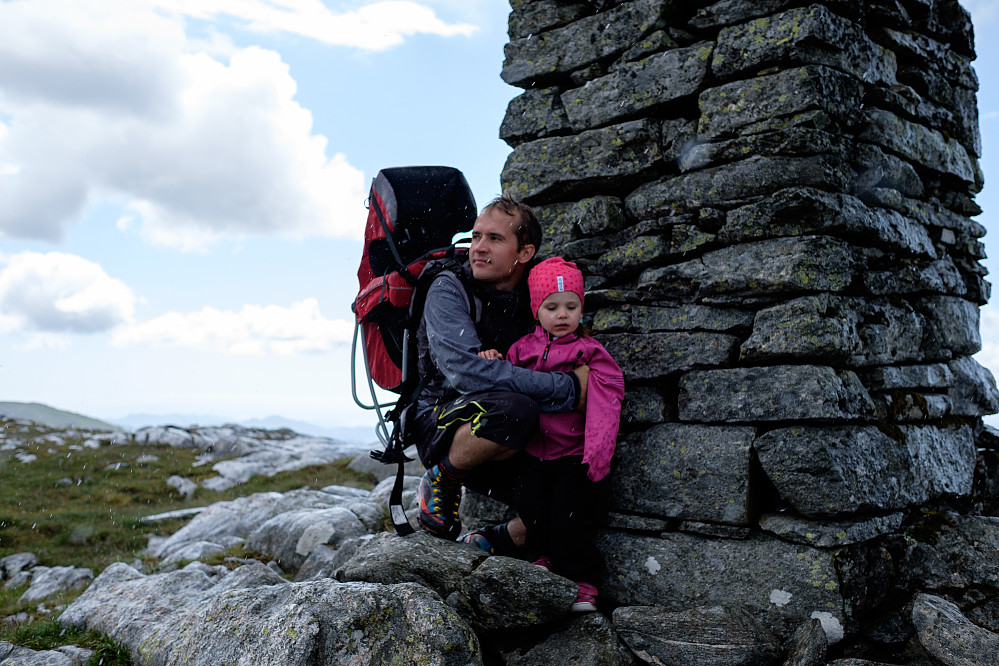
[[0, 448, 999, 666]]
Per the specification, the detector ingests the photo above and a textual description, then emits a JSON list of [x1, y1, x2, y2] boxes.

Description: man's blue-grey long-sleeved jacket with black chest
[[417, 264, 578, 412]]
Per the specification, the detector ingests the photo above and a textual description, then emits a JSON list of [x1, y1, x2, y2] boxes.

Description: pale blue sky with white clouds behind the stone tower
[[0, 0, 999, 426]]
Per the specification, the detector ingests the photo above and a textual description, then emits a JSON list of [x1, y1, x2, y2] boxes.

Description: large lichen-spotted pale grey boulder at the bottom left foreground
[[59, 564, 482, 666]]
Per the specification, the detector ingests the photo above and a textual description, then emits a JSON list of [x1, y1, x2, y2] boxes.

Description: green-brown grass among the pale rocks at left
[[0, 419, 372, 665]]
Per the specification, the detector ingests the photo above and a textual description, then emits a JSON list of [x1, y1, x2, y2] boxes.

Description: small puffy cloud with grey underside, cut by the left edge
[[0, 252, 135, 340]]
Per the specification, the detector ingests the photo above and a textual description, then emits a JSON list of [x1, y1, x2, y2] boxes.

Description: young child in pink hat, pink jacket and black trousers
[[472, 257, 624, 611]]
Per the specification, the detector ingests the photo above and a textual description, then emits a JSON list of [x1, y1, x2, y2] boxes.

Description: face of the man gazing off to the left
[[469, 207, 534, 289]]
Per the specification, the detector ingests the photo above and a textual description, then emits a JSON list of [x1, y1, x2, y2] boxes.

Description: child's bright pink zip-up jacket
[[506, 326, 624, 481]]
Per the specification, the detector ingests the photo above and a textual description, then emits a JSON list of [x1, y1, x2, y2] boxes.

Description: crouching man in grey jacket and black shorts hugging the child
[[407, 195, 589, 550]]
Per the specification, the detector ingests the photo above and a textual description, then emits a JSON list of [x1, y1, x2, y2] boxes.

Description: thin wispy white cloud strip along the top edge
[[153, 0, 478, 51]]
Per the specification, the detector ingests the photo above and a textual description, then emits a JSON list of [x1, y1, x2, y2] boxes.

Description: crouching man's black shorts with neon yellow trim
[[406, 391, 541, 503]]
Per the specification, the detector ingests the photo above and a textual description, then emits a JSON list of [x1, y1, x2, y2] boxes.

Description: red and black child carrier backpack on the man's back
[[351, 166, 476, 535]]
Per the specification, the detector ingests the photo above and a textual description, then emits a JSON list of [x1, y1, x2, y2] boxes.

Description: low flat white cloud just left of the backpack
[[114, 298, 354, 356]]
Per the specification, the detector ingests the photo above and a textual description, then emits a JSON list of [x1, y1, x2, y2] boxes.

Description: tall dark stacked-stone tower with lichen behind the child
[[500, 0, 999, 652]]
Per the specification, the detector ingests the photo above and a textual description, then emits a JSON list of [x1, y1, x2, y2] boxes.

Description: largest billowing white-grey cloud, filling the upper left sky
[[0, 0, 378, 250]]
